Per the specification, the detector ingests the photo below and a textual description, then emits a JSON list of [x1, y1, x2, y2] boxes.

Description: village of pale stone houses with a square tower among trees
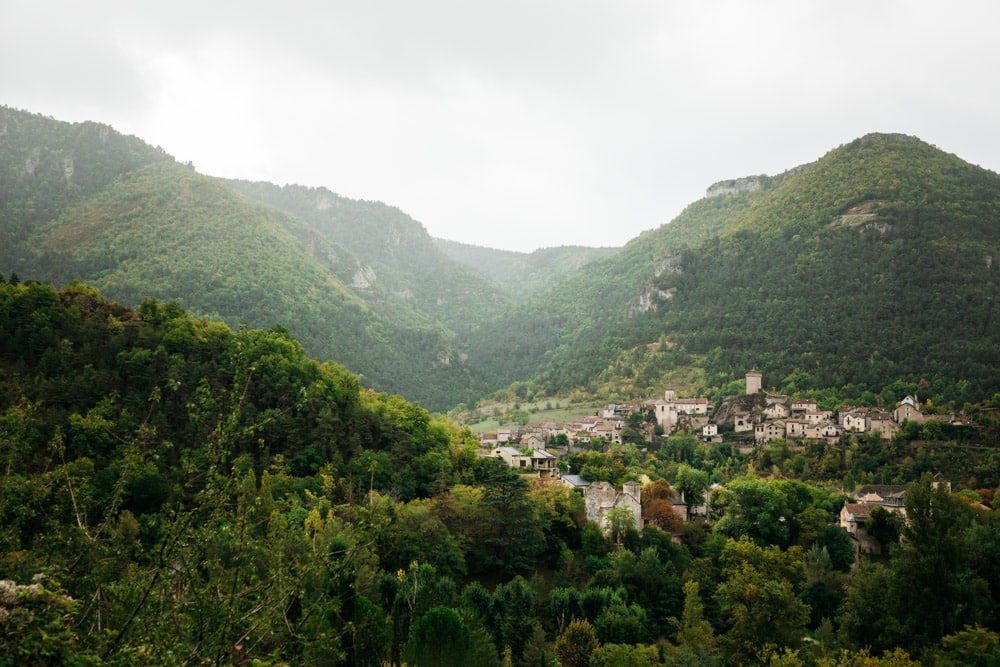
[[479, 370, 968, 554]]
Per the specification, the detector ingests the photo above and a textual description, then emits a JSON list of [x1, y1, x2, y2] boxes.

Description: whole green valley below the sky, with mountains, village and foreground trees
[[0, 107, 1000, 667]]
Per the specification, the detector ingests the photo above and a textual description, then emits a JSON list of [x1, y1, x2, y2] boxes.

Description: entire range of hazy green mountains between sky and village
[[0, 108, 1000, 410]]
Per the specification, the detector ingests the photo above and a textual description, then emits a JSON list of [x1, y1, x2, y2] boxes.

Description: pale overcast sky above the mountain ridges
[[0, 0, 1000, 252]]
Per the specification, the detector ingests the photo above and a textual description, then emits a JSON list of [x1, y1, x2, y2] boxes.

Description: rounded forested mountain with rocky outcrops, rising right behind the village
[[470, 134, 1000, 404]]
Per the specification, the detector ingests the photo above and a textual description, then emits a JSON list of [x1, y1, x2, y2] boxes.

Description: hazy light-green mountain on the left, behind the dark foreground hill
[[0, 109, 492, 409]]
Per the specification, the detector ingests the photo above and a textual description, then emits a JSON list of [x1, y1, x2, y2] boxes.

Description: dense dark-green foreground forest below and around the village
[[0, 275, 1000, 666]]
